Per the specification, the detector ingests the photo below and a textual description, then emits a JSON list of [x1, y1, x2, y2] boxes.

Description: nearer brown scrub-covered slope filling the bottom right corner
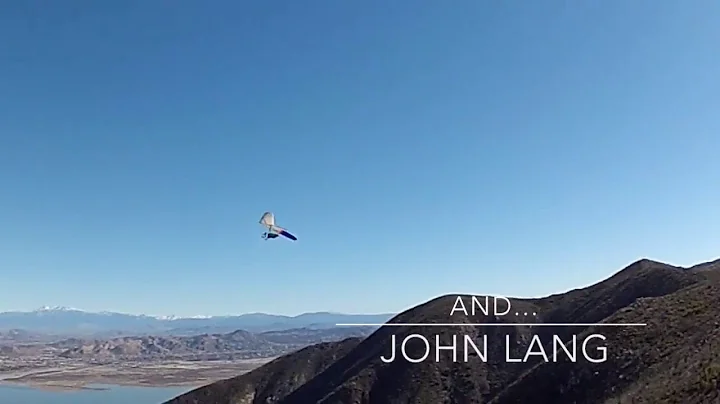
[[491, 282, 720, 404]]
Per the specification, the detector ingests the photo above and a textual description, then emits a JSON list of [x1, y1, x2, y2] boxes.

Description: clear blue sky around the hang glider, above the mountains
[[0, 0, 720, 315]]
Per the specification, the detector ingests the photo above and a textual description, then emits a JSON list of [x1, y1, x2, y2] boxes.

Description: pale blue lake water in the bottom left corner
[[0, 385, 193, 404]]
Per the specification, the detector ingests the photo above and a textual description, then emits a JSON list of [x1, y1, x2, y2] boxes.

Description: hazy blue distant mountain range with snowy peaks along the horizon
[[0, 307, 394, 336]]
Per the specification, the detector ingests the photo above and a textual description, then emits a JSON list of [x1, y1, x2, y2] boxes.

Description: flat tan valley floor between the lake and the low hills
[[0, 358, 274, 390]]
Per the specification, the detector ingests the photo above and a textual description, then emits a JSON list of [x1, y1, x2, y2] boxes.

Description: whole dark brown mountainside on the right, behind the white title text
[[163, 260, 720, 404]]
